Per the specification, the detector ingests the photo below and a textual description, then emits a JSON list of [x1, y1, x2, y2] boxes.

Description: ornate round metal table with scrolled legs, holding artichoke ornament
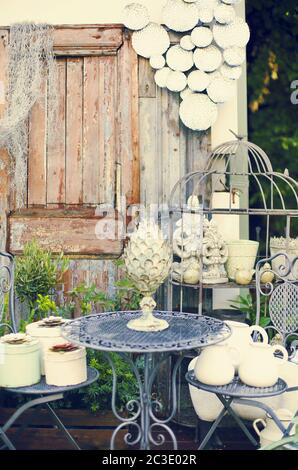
[[62, 311, 231, 449]]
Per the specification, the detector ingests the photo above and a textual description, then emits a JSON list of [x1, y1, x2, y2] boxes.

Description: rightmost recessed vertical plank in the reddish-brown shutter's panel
[[99, 57, 117, 206]]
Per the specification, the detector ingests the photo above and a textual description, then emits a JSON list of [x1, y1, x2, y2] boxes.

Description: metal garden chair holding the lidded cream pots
[[0, 252, 99, 450]]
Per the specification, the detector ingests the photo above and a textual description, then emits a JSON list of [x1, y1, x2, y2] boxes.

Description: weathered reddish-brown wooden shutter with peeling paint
[[4, 25, 139, 255]]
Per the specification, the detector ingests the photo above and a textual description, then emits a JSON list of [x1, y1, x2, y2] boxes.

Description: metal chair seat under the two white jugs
[[185, 370, 288, 398]]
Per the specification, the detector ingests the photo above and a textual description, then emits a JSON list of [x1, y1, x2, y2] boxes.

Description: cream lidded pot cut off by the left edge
[[0, 339, 40, 387]]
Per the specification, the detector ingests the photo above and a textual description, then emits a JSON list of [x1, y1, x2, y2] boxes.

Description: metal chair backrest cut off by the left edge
[[0, 251, 17, 333]]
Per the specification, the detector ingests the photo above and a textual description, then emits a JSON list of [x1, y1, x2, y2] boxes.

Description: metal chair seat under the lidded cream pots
[[3, 367, 99, 395]]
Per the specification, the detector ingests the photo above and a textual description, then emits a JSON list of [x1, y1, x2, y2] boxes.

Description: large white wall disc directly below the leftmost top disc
[[132, 23, 170, 59]]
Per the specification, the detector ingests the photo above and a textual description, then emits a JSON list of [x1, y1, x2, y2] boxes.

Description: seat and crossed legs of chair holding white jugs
[[185, 370, 293, 450]]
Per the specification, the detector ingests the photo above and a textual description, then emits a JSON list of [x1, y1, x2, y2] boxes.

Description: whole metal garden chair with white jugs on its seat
[[186, 254, 298, 450]]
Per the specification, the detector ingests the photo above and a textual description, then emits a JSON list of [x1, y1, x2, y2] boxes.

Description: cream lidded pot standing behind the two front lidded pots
[[26, 319, 65, 375]]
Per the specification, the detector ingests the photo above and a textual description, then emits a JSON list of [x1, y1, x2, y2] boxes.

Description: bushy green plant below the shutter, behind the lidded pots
[[15, 240, 69, 309]]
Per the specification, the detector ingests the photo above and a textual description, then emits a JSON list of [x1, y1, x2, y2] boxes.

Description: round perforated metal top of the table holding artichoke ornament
[[62, 311, 231, 353]]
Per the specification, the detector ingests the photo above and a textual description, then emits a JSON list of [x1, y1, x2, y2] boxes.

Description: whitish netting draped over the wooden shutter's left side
[[0, 23, 57, 207]]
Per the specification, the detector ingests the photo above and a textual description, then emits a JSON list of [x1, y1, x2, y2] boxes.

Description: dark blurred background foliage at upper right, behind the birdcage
[[246, 0, 298, 235]]
